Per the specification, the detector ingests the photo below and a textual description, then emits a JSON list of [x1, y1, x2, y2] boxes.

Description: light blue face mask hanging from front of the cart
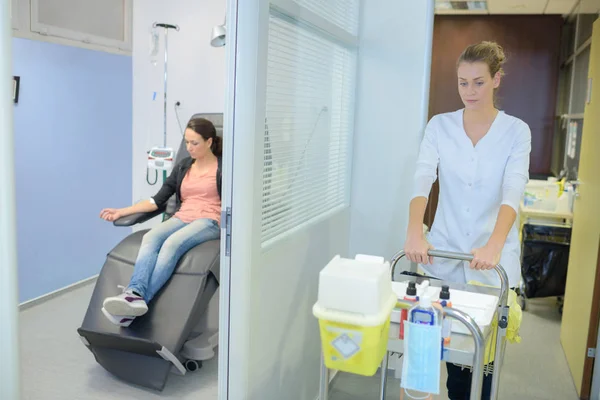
[[400, 321, 442, 394]]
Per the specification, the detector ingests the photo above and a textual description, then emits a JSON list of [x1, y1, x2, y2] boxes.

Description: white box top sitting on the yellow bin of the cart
[[318, 255, 394, 315]]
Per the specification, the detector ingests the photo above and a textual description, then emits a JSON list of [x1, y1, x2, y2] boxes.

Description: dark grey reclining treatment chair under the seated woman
[[77, 114, 223, 391]]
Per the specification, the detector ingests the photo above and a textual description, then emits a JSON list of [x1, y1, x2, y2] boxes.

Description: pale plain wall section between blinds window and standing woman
[[350, 0, 433, 268]]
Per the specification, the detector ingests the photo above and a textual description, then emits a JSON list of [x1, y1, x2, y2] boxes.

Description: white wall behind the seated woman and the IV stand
[[133, 0, 225, 229]]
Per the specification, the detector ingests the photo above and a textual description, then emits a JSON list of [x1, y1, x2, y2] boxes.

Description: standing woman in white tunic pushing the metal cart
[[404, 42, 531, 400]]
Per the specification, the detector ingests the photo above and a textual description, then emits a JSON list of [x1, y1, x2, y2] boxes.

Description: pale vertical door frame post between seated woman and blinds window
[[218, 0, 269, 400]]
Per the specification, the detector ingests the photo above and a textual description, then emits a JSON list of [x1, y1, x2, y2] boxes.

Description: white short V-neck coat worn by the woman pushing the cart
[[413, 109, 531, 287]]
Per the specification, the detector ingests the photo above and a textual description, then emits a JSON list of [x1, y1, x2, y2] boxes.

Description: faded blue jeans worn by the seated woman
[[128, 217, 221, 303]]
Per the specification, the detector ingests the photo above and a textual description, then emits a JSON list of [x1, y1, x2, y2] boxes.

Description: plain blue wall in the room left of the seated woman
[[12, 38, 132, 302]]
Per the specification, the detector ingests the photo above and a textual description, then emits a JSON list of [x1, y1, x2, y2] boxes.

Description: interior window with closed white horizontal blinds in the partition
[[261, 0, 357, 247]]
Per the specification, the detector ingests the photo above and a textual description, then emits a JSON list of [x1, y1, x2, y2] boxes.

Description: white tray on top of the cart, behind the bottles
[[391, 282, 499, 335]]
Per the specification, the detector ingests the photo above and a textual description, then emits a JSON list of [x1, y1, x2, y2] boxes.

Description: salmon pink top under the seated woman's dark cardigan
[[174, 161, 221, 224]]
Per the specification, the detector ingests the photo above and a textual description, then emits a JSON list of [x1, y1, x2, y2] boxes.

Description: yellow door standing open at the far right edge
[[560, 19, 600, 399]]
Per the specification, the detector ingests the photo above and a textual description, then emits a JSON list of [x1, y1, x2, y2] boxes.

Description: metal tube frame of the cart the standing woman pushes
[[319, 250, 509, 400]]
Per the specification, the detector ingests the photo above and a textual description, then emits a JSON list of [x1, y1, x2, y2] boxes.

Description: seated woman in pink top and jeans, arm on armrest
[[100, 118, 222, 327]]
